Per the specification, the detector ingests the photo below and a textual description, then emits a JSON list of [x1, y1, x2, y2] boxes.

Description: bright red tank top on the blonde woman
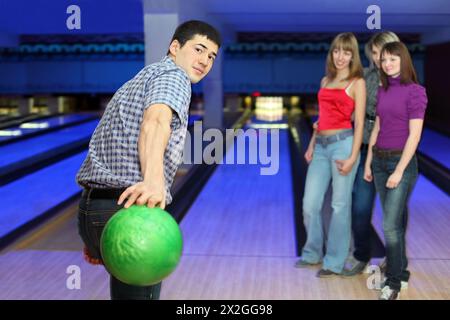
[[317, 81, 355, 131]]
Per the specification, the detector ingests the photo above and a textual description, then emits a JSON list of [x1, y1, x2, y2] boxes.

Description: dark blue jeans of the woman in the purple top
[[372, 154, 418, 290]]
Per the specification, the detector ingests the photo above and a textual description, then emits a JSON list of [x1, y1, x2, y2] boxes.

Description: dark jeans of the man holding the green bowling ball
[[78, 190, 161, 300]]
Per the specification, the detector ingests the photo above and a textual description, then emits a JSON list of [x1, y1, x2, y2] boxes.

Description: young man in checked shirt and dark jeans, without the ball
[[76, 21, 221, 300]]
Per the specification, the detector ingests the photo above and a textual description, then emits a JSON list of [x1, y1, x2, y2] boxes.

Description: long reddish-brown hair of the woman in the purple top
[[380, 41, 419, 90]]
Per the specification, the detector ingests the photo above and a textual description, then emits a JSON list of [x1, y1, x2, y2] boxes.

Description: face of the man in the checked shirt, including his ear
[[169, 35, 219, 83]]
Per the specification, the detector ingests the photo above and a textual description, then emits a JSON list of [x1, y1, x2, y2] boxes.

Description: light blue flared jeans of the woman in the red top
[[302, 132, 359, 273]]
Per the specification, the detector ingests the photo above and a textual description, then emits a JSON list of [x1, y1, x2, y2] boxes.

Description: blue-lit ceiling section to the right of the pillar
[[203, 0, 450, 33]]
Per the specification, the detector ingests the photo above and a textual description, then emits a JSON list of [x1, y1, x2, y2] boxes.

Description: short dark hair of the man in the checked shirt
[[170, 20, 221, 52]]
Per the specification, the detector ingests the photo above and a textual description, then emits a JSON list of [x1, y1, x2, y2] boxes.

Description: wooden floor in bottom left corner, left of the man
[[0, 202, 109, 300]]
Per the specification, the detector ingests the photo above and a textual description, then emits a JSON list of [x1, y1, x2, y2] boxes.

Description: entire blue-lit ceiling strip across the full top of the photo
[[0, 0, 450, 37]]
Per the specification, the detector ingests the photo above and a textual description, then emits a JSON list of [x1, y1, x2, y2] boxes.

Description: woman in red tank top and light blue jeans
[[296, 33, 366, 277]]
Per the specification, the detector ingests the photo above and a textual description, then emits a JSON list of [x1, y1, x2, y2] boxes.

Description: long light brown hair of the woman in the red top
[[326, 32, 363, 80]]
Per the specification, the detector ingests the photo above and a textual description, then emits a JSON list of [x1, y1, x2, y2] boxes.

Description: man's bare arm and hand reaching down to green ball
[[118, 104, 172, 209]]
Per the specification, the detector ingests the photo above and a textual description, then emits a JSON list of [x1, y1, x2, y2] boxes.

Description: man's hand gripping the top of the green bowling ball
[[117, 181, 166, 209]]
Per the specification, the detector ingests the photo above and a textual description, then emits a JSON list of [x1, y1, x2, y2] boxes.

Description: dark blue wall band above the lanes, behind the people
[[0, 42, 424, 95]]
